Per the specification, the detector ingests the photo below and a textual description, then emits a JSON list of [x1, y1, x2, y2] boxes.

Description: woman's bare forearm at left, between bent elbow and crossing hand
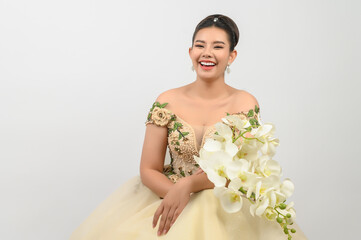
[[140, 169, 174, 198]]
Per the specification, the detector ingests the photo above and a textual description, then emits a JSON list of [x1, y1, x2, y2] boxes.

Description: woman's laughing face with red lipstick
[[189, 27, 237, 79]]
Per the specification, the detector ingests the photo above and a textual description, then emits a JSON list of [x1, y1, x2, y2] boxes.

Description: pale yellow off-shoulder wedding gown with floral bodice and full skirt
[[70, 102, 307, 240]]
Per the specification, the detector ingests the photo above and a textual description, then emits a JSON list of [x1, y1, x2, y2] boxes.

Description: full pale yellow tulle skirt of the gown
[[70, 175, 307, 240]]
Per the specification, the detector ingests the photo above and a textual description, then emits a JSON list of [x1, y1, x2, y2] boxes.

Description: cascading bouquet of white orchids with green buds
[[194, 105, 296, 239]]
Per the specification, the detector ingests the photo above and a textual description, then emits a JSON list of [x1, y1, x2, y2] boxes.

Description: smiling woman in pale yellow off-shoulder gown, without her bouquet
[[70, 14, 306, 240]]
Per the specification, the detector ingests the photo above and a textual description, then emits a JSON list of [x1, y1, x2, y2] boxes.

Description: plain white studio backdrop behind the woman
[[0, 0, 361, 240]]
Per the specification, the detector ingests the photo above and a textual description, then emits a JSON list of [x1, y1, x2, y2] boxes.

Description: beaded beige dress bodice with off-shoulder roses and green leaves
[[145, 102, 259, 183]]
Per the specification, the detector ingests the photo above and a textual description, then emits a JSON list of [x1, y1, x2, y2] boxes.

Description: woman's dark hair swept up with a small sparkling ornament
[[192, 14, 239, 52]]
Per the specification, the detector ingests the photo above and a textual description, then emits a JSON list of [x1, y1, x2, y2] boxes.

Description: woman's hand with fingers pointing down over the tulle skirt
[[153, 178, 191, 236]]
